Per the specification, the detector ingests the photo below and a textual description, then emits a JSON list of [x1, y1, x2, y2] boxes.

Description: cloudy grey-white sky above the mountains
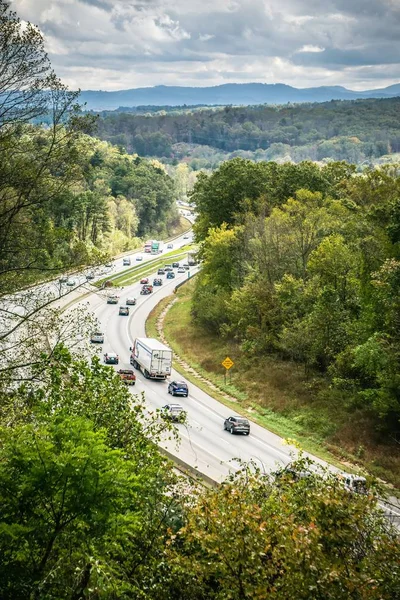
[[11, 0, 400, 91]]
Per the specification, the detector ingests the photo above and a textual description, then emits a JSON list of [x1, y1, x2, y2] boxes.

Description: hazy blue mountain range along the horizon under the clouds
[[80, 83, 400, 111]]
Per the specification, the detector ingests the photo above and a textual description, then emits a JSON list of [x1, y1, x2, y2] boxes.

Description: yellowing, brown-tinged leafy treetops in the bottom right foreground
[[157, 460, 400, 600]]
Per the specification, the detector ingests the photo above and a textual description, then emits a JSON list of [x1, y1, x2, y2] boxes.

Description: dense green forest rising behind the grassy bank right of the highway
[[191, 159, 400, 440]]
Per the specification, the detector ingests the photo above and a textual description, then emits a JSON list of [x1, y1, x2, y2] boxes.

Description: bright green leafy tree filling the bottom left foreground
[[0, 346, 183, 600]]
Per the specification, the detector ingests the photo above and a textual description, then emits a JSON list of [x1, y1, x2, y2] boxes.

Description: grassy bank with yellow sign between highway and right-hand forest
[[146, 282, 400, 488]]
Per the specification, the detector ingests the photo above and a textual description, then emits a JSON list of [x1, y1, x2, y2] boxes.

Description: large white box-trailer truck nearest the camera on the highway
[[130, 338, 172, 379]]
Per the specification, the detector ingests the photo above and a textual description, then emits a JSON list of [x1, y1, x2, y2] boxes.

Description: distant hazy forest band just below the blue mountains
[[97, 98, 400, 168]]
